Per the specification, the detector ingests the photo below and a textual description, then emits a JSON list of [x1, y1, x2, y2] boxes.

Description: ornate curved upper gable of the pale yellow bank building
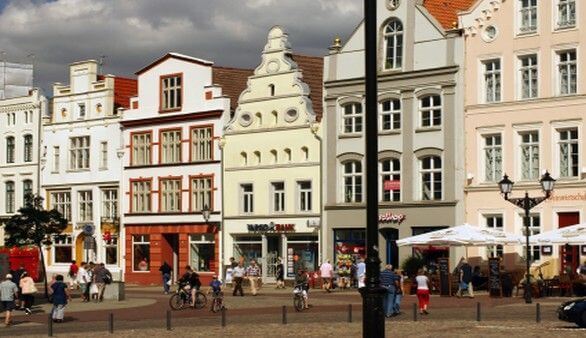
[[226, 26, 316, 131]]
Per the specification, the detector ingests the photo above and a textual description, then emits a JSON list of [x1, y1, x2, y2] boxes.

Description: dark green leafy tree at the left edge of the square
[[4, 194, 67, 297]]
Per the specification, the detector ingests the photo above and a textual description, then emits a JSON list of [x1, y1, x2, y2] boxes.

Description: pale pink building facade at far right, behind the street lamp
[[460, 0, 586, 274]]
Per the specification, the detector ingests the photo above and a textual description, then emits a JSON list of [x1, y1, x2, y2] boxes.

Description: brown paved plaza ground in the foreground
[[0, 287, 586, 337]]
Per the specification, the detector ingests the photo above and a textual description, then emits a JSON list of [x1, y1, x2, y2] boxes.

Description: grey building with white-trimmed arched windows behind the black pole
[[322, 0, 473, 266]]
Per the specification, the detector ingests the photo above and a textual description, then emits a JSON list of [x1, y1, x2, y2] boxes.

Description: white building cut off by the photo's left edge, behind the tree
[[0, 89, 48, 244]]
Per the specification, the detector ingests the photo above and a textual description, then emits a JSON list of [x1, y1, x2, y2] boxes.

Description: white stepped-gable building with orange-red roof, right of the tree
[[41, 60, 137, 280]]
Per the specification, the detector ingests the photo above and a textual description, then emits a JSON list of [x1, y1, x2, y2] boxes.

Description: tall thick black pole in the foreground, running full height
[[361, 0, 386, 338]]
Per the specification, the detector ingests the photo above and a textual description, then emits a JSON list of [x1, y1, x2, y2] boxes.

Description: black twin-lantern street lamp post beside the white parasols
[[499, 171, 555, 304]]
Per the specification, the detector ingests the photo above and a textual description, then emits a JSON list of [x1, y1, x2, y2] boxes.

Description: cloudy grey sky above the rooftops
[[0, 0, 362, 95]]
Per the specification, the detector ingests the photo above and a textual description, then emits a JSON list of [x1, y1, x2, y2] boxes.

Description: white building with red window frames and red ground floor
[[122, 53, 246, 284]]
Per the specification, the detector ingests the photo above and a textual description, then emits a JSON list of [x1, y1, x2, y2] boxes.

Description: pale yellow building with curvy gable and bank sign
[[222, 27, 322, 281]]
